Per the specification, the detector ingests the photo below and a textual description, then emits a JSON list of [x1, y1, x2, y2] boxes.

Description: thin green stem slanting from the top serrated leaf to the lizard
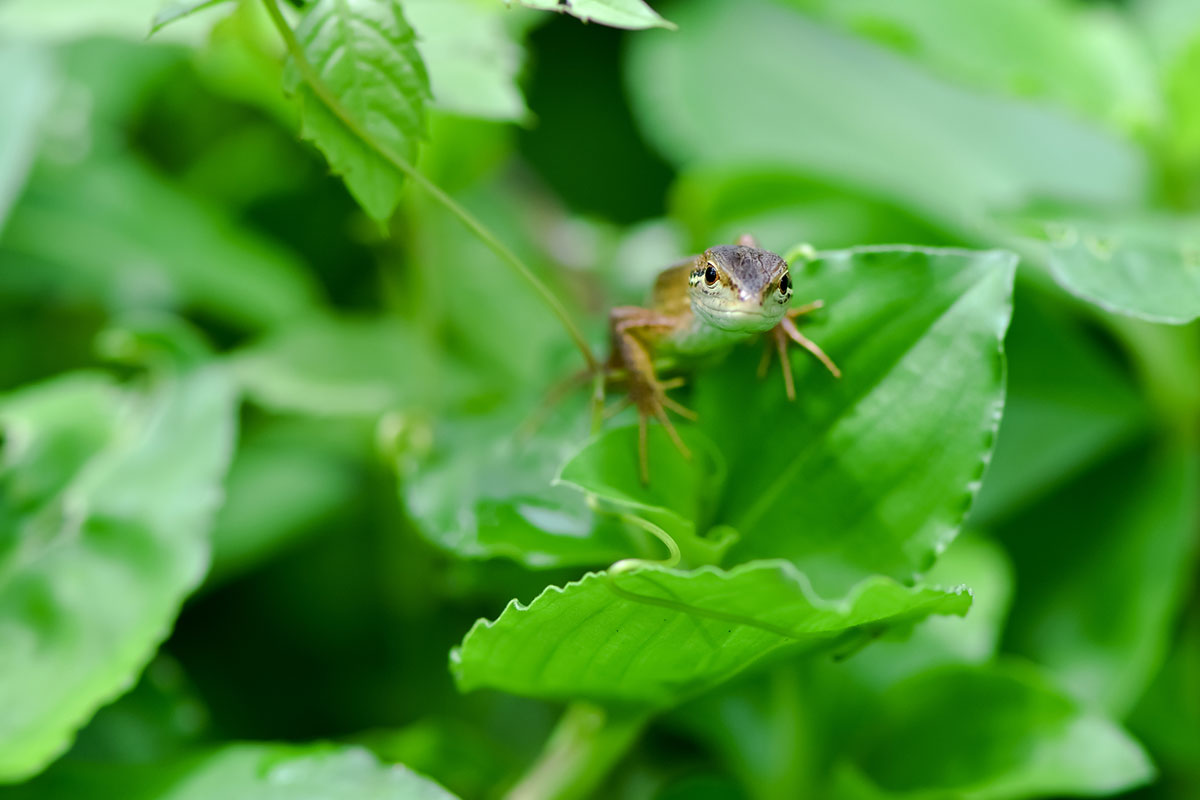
[[263, 0, 600, 372]]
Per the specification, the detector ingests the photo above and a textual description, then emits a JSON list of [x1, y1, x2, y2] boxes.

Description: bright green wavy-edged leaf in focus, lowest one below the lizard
[[451, 561, 971, 706]]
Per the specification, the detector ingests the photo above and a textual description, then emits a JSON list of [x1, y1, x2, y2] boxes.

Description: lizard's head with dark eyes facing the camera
[[688, 245, 792, 333]]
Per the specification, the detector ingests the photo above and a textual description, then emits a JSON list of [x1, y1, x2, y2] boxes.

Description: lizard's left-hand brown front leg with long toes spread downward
[[608, 306, 695, 485]]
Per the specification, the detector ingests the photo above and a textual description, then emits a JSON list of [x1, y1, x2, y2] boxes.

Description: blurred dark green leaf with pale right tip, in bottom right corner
[[836, 663, 1154, 800]]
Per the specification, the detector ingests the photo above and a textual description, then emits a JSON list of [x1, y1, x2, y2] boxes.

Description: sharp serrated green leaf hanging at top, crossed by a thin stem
[[284, 0, 430, 222]]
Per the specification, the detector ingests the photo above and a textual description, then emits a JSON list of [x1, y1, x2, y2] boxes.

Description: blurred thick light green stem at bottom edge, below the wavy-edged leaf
[[506, 702, 650, 800]]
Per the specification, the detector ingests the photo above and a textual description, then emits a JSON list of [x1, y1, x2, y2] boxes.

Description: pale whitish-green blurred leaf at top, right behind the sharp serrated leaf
[[404, 0, 529, 120]]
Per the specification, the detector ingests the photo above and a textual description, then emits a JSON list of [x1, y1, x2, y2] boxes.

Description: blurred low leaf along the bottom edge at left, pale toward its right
[[0, 744, 454, 800]]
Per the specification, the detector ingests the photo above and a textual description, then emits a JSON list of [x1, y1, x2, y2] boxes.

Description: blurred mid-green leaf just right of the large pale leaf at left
[[208, 417, 368, 585]]
